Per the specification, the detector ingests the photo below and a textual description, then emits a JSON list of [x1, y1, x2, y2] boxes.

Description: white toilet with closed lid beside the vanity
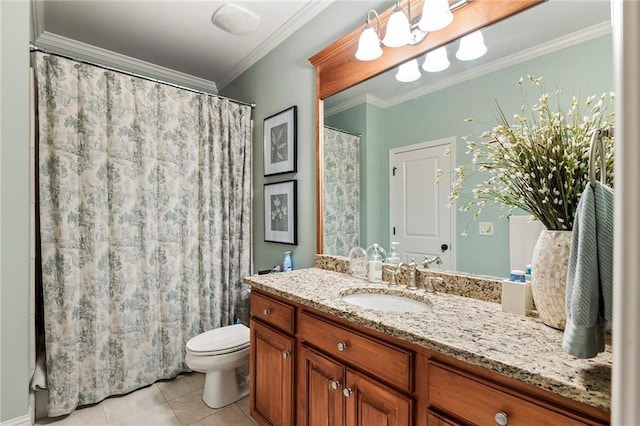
[[185, 324, 250, 408]]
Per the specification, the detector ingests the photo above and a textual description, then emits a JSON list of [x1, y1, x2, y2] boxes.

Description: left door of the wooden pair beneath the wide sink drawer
[[298, 346, 344, 426]]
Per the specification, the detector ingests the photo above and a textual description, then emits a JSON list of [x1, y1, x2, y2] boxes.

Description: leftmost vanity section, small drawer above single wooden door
[[249, 294, 296, 426]]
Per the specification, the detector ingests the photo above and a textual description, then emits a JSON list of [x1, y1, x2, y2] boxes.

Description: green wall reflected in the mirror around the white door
[[328, 35, 613, 276]]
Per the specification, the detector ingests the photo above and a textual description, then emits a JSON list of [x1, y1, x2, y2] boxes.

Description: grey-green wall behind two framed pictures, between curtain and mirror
[[220, 1, 388, 270]]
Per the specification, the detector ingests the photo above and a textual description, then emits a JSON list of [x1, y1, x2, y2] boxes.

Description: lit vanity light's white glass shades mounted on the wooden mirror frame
[[356, 0, 468, 61]]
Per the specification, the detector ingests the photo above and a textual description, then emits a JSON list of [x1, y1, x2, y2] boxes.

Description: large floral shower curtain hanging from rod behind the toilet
[[36, 53, 251, 416]]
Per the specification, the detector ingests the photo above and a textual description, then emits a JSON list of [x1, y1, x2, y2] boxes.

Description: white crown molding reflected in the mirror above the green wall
[[330, 21, 612, 114]]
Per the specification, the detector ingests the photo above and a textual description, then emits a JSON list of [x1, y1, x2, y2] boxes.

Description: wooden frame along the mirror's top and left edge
[[309, 0, 545, 254]]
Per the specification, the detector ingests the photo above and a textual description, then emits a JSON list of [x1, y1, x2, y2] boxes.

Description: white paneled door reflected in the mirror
[[389, 138, 455, 270]]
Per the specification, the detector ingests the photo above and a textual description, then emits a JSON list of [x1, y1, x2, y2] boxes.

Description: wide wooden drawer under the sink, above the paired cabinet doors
[[298, 312, 414, 392]]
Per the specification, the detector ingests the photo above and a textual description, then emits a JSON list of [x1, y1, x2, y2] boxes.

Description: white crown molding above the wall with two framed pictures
[[217, 0, 334, 89]]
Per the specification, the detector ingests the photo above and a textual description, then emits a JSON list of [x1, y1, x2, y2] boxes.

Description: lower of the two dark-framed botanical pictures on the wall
[[264, 179, 298, 245]]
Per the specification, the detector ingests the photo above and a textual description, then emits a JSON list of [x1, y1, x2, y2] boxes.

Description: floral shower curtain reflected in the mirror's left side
[[322, 126, 360, 256]]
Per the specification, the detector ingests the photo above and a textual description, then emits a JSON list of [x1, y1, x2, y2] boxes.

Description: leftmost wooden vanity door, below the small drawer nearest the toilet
[[250, 319, 294, 426]]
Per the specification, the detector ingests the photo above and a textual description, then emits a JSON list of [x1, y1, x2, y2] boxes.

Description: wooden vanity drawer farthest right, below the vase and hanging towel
[[428, 364, 584, 426]]
